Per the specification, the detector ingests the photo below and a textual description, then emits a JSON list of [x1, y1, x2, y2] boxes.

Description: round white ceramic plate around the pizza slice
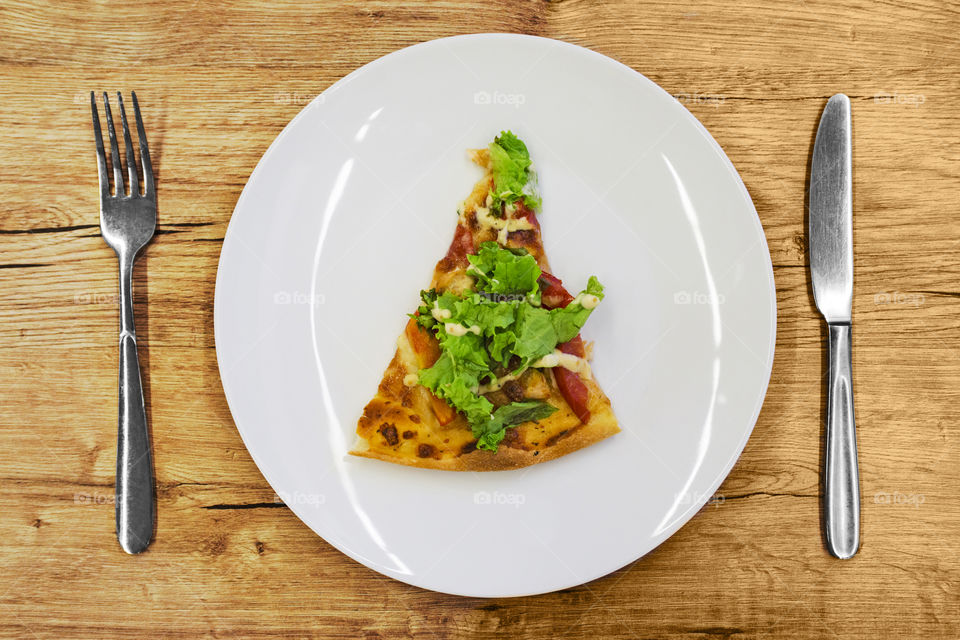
[[214, 35, 776, 596]]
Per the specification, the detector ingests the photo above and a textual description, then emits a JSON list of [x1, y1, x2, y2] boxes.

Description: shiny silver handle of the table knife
[[823, 324, 860, 559]]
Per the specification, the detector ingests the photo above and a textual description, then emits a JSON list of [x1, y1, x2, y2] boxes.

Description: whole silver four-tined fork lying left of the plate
[[90, 91, 157, 553]]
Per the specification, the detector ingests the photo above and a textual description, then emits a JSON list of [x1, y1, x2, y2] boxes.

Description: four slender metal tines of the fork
[[90, 91, 154, 198]]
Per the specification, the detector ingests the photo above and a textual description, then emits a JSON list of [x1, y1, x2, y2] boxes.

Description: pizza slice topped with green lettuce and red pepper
[[350, 131, 620, 471]]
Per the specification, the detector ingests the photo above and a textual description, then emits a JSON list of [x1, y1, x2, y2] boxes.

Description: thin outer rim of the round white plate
[[213, 32, 777, 598]]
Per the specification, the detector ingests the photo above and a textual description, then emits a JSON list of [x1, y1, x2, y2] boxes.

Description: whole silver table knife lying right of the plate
[[809, 93, 860, 559]]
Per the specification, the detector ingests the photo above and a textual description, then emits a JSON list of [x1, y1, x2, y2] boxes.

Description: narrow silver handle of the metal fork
[[116, 256, 155, 553]]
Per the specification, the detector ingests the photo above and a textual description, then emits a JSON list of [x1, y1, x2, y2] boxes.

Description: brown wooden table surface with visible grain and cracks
[[0, 0, 960, 639]]
